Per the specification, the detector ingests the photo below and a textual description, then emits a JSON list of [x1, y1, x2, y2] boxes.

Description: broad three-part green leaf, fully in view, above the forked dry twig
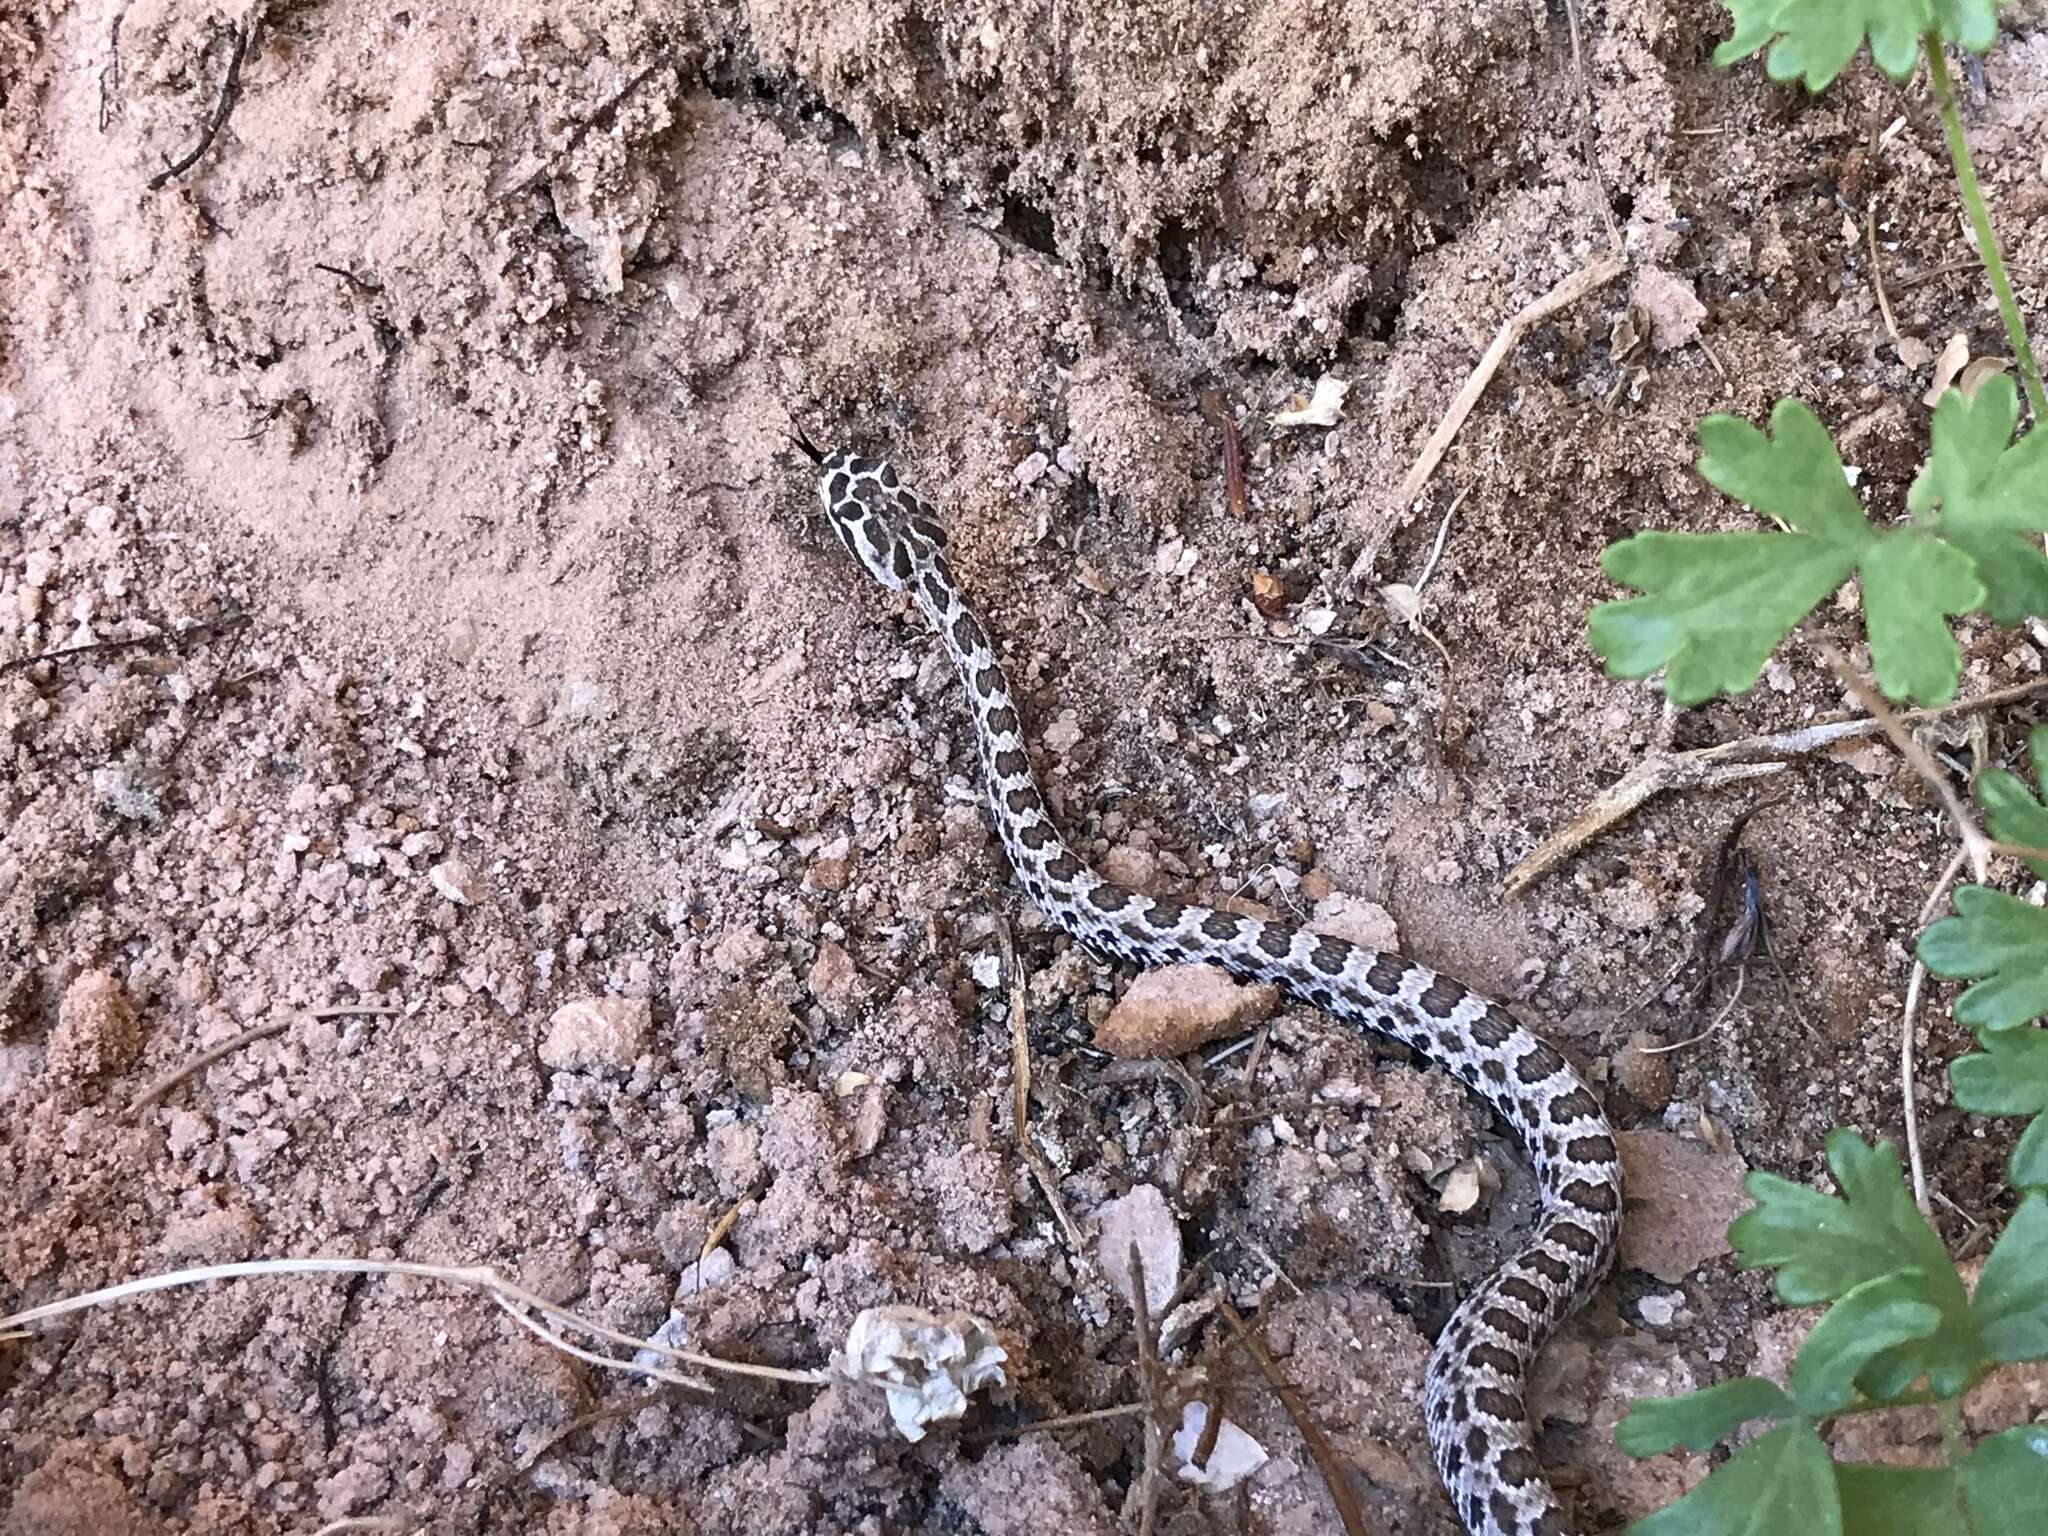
[[1587, 399, 1982, 705]]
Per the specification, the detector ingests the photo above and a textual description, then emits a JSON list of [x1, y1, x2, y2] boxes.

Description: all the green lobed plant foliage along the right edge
[[1587, 0, 2048, 1536]]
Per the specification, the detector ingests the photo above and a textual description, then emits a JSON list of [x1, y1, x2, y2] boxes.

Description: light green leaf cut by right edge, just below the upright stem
[[1907, 377, 2048, 625]]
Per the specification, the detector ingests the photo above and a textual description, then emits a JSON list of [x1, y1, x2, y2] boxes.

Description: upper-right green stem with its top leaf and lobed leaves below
[[1587, 0, 2048, 705]]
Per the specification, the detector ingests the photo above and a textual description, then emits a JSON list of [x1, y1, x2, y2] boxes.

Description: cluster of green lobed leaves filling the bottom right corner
[[1616, 1130, 2048, 1536]]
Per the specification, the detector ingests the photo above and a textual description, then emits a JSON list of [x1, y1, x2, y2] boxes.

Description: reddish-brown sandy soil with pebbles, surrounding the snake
[[0, 0, 2048, 1536]]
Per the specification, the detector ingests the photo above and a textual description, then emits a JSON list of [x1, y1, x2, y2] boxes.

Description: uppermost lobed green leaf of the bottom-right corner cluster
[[1729, 1130, 1985, 1401]]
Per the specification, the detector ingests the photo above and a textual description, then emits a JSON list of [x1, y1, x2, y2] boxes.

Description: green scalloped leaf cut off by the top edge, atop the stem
[[1714, 0, 1999, 90]]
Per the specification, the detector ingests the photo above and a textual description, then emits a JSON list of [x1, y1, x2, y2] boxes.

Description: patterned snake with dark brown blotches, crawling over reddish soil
[[793, 436, 1622, 1536]]
